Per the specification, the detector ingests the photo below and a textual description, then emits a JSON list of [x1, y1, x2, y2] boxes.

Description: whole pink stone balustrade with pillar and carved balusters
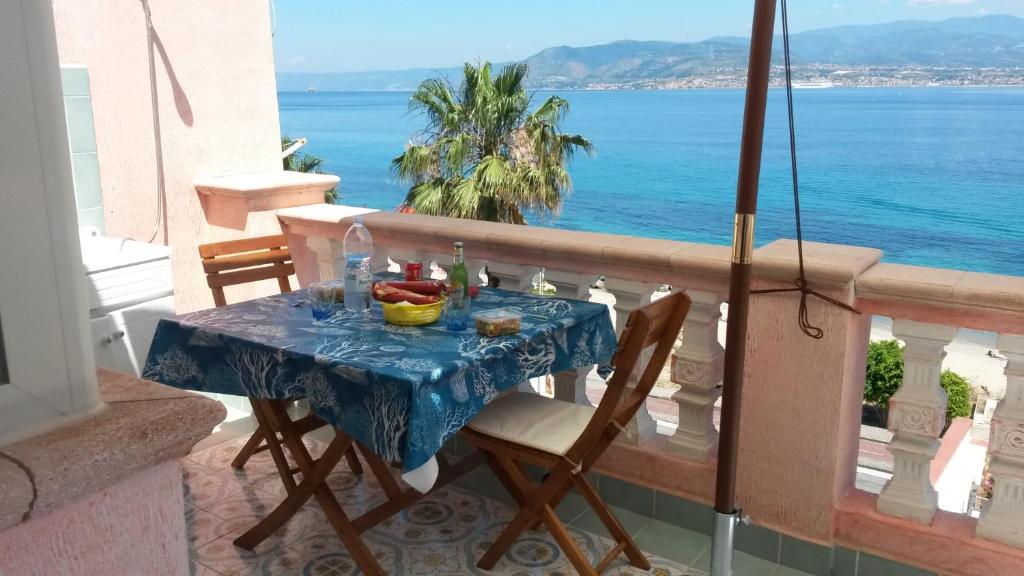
[[279, 205, 1024, 574]]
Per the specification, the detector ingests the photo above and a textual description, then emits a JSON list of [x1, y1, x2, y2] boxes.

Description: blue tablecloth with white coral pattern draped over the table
[[143, 288, 615, 471]]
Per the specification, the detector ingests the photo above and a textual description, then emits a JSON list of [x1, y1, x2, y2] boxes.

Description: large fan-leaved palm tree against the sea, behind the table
[[391, 63, 593, 224]]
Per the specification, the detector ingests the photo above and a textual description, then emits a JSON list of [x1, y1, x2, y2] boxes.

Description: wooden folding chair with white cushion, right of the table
[[463, 292, 690, 575]]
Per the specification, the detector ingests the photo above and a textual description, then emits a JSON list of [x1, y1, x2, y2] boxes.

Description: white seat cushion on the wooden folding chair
[[468, 393, 596, 455]]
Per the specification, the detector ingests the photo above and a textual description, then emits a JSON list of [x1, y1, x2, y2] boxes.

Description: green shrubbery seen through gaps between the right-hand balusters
[[864, 340, 971, 423]]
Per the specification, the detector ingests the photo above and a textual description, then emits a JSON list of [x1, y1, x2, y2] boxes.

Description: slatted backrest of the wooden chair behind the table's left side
[[199, 235, 295, 306]]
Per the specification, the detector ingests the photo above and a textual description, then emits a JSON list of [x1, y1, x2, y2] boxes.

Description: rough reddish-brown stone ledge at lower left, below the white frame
[[0, 370, 226, 530]]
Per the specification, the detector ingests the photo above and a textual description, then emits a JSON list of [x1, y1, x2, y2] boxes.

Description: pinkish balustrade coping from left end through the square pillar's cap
[[278, 204, 882, 291]]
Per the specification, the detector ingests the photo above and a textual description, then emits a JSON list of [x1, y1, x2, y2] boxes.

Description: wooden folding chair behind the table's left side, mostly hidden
[[199, 235, 362, 474]]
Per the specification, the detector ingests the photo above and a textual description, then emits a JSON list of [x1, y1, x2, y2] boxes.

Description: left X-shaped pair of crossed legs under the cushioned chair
[[476, 453, 597, 576]]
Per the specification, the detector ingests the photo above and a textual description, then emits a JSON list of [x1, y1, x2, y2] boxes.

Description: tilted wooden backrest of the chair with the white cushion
[[569, 292, 690, 456]]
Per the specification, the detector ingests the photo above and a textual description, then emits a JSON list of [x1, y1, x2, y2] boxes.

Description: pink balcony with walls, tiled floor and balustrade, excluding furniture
[[0, 0, 1024, 576]]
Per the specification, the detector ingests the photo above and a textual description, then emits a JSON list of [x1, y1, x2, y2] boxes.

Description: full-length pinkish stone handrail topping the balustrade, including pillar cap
[[278, 204, 1024, 334]]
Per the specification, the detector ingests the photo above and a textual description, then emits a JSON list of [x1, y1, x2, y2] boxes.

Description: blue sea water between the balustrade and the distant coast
[[279, 88, 1024, 276]]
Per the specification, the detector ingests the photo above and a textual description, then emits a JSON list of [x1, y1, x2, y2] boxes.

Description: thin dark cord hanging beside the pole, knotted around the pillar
[[751, 0, 860, 339]]
